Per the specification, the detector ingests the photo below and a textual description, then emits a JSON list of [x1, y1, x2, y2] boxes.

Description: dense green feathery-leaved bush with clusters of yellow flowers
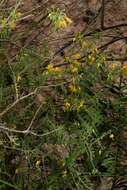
[[0, 1, 127, 190]]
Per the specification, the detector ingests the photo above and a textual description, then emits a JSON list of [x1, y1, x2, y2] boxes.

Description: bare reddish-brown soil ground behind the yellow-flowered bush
[[6, 0, 127, 62]]
